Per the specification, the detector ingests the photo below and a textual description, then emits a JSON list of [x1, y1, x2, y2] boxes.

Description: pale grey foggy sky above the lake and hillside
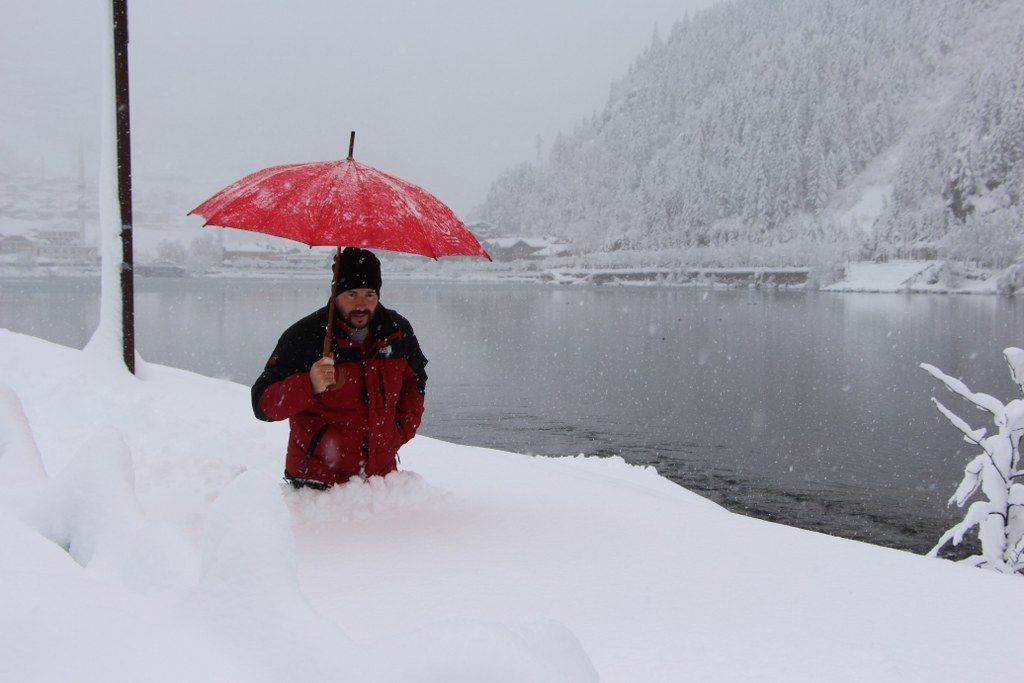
[[0, 0, 713, 214]]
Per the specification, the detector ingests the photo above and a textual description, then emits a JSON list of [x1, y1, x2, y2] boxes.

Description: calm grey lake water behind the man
[[0, 278, 1024, 552]]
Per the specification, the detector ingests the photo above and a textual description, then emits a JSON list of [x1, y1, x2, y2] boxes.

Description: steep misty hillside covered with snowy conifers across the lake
[[478, 0, 1024, 265]]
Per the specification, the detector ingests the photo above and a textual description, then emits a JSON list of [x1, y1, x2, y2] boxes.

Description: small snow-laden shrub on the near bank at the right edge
[[921, 348, 1024, 573]]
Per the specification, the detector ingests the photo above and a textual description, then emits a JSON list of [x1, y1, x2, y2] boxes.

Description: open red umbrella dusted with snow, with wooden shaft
[[188, 132, 490, 355]]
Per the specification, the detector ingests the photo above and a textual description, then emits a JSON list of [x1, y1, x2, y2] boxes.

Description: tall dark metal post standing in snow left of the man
[[113, 0, 135, 374]]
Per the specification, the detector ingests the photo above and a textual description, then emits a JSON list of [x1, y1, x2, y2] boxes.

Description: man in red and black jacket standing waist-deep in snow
[[252, 248, 427, 489]]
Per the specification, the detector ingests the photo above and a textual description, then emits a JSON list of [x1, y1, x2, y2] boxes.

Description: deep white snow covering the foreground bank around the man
[[0, 330, 1024, 682]]
